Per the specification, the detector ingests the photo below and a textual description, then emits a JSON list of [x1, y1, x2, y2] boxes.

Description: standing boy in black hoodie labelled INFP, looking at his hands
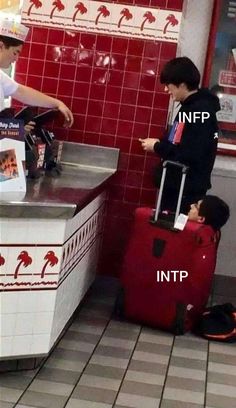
[[139, 57, 220, 213]]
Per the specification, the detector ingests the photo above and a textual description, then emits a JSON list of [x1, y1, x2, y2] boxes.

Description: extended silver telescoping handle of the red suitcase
[[154, 160, 188, 225]]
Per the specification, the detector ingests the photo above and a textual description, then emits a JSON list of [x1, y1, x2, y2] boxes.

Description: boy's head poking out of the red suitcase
[[188, 195, 230, 231]]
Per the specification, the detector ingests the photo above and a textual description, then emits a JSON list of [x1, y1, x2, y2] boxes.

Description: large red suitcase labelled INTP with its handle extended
[[121, 162, 218, 334]]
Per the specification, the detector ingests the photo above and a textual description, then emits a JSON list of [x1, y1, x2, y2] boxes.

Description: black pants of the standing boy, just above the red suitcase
[[161, 188, 206, 214]]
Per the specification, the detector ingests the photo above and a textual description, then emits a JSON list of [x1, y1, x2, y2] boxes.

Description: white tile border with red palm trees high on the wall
[[21, 0, 182, 43]]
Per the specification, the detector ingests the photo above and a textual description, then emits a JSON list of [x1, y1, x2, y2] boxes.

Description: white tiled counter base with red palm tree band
[[0, 193, 106, 359]]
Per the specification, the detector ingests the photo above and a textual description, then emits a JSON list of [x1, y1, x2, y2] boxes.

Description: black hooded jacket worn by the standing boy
[[154, 89, 220, 194]]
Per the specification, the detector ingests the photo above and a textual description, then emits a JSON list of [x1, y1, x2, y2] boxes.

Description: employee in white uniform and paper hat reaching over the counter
[[0, 19, 73, 127]]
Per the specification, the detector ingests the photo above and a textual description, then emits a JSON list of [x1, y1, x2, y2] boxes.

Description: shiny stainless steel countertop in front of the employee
[[0, 142, 119, 219]]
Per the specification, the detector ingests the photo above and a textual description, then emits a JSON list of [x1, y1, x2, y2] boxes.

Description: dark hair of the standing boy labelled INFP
[[160, 57, 200, 91]]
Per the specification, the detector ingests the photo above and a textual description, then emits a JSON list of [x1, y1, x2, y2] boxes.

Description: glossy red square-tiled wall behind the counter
[[16, 0, 183, 275]]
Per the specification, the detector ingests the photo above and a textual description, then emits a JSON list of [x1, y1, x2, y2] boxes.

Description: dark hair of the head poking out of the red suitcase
[[198, 195, 230, 230]]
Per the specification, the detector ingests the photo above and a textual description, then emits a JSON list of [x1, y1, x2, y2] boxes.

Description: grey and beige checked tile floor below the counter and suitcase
[[0, 279, 236, 408]]
